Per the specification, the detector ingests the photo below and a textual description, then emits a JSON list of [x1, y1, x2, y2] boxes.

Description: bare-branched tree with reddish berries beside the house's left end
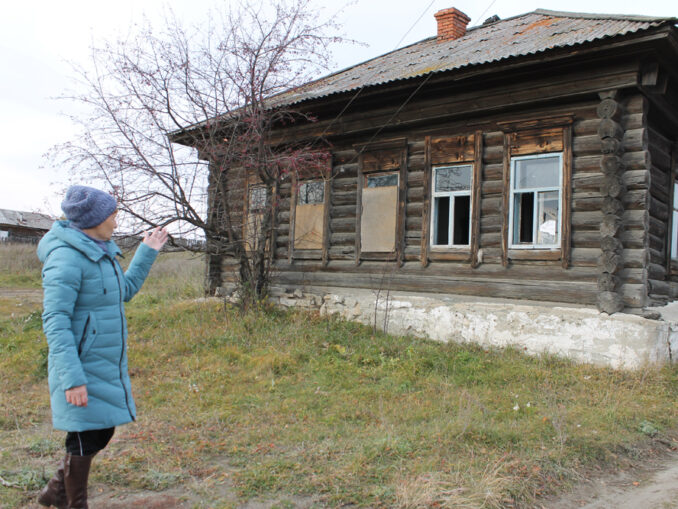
[[54, 0, 340, 301]]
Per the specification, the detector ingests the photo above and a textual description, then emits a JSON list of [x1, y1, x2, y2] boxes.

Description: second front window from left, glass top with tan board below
[[294, 181, 325, 249]]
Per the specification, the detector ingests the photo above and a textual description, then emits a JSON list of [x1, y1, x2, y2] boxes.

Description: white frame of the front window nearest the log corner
[[508, 152, 563, 250]]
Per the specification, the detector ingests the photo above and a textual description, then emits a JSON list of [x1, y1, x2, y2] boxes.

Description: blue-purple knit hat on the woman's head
[[61, 186, 118, 229]]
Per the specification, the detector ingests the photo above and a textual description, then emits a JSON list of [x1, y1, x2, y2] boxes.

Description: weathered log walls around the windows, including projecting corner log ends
[[218, 92, 678, 313]]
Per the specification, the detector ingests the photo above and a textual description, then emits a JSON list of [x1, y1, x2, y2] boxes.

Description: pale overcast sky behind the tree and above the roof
[[0, 0, 678, 215]]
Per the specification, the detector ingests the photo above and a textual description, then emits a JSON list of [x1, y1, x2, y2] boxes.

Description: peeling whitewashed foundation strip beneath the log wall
[[220, 287, 678, 369]]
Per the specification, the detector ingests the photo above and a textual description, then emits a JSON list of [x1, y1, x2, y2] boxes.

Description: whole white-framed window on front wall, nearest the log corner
[[509, 154, 562, 249]]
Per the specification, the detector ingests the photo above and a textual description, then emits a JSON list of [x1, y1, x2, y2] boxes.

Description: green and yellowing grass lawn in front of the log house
[[0, 244, 678, 507]]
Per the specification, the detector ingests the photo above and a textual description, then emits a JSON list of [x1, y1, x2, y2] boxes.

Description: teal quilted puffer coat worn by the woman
[[38, 221, 158, 431]]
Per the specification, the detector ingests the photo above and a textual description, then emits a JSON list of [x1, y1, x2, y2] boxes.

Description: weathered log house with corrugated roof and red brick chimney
[[174, 9, 678, 366]]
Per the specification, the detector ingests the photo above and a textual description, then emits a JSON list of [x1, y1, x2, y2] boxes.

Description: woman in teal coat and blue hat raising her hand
[[38, 186, 167, 508]]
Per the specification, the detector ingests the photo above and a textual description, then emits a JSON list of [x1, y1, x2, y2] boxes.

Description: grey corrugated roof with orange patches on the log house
[[271, 9, 676, 106]]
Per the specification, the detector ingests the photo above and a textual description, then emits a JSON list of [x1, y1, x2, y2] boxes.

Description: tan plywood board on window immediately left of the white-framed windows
[[360, 186, 398, 253]]
